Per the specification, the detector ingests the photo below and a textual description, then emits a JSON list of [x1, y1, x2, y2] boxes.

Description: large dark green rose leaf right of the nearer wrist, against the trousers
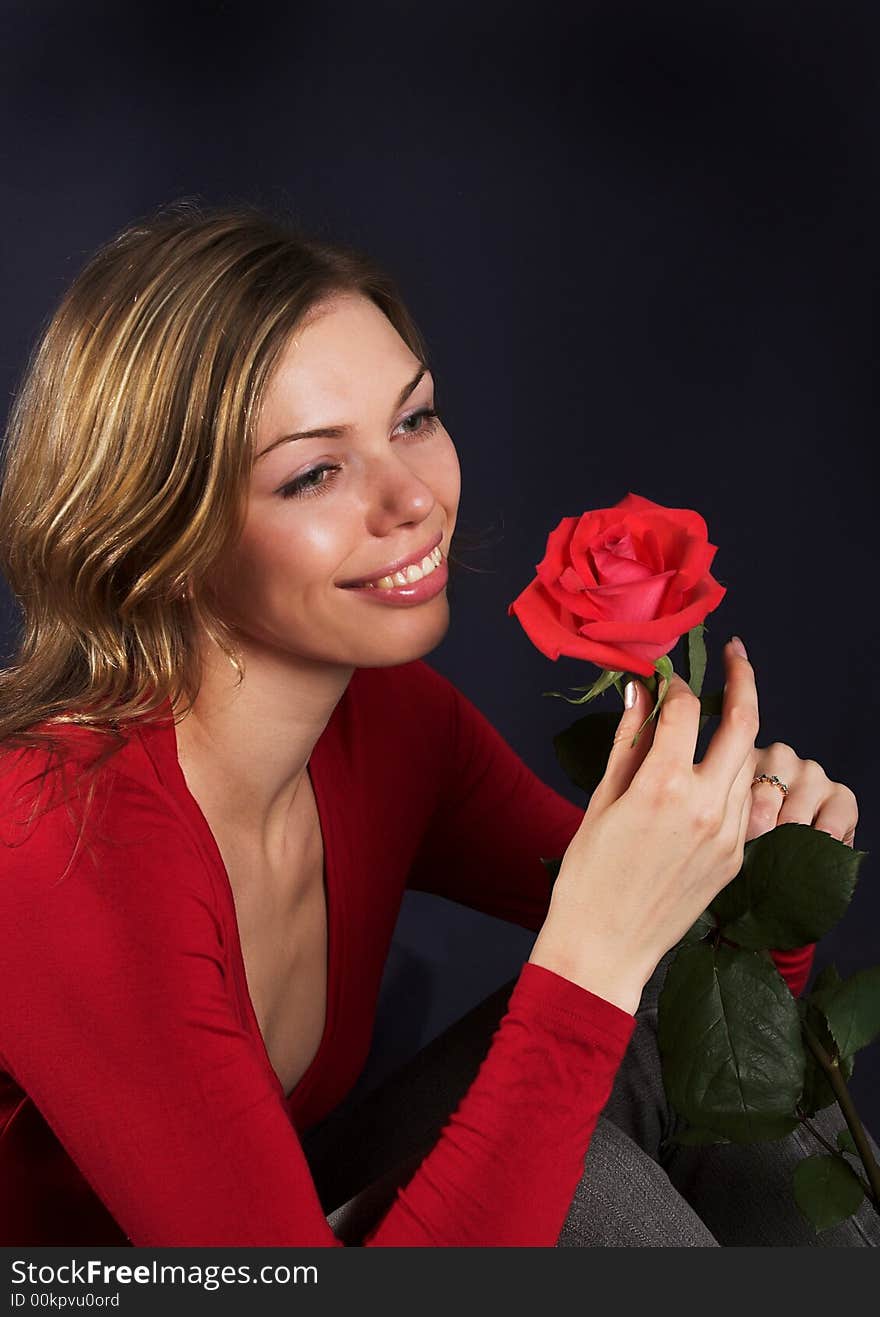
[[657, 942, 804, 1143]]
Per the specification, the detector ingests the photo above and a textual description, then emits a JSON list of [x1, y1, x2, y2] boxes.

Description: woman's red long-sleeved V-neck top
[[0, 660, 811, 1247]]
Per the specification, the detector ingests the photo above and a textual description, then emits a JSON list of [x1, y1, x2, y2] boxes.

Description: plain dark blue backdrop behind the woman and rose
[[0, 0, 880, 1134]]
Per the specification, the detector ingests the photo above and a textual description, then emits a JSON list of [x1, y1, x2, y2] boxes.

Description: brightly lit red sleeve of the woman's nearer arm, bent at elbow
[[0, 774, 635, 1247]]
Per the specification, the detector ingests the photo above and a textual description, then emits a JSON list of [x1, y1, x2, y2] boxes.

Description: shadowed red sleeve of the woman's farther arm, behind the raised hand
[[407, 664, 815, 996]]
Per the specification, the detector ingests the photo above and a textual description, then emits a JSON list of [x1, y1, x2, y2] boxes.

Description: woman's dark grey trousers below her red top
[[303, 952, 880, 1249]]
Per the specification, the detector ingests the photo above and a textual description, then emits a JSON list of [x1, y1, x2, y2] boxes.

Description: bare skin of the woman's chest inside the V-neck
[[208, 785, 328, 1097]]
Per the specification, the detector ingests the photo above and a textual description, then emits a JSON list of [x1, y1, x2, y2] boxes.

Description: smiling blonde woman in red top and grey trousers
[[0, 207, 876, 1246]]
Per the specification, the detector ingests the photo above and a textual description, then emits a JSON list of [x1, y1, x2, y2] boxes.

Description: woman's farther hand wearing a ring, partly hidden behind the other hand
[[746, 741, 859, 846]]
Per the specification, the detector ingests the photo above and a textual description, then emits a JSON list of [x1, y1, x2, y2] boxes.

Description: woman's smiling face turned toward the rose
[[205, 294, 460, 668]]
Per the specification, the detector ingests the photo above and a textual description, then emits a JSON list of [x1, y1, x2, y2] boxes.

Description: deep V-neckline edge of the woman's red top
[[164, 718, 341, 1108]]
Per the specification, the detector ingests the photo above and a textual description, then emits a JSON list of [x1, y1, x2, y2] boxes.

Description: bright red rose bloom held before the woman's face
[[507, 494, 727, 677]]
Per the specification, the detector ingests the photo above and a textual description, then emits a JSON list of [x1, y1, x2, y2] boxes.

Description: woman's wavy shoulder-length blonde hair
[[0, 194, 440, 853]]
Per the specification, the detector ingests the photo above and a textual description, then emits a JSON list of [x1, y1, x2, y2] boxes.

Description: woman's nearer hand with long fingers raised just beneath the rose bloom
[[528, 643, 760, 1014]]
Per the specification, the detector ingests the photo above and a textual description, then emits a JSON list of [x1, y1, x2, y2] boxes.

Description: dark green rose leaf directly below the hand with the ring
[[709, 823, 868, 951]]
